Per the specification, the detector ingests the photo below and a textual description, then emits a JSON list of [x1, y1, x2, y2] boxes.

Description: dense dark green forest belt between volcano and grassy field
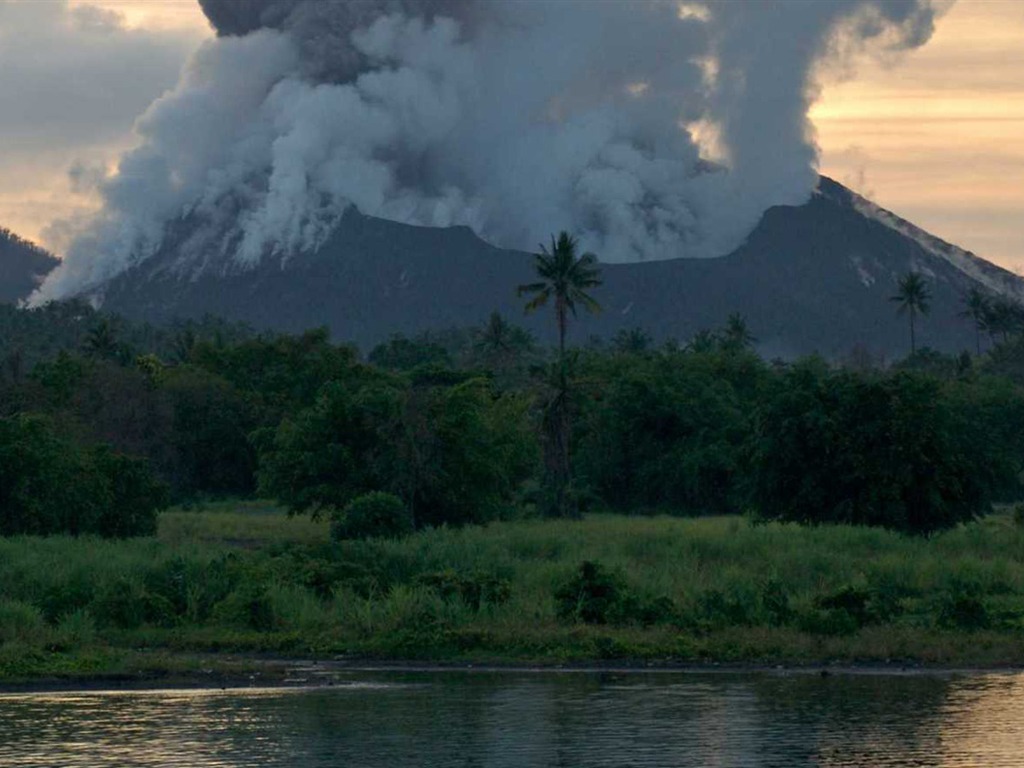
[[6, 264, 1024, 537]]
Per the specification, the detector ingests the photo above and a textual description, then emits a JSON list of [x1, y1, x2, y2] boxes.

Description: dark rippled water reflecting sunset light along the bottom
[[0, 672, 1024, 768]]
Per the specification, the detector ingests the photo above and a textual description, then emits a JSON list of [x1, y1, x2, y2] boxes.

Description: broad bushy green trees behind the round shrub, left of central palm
[[260, 376, 534, 527]]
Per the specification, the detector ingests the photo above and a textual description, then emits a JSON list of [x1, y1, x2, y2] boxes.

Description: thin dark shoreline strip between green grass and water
[[0, 655, 1024, 697]]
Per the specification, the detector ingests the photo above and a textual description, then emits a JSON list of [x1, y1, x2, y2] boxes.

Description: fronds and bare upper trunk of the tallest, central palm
[[518, 231, 601, 361]]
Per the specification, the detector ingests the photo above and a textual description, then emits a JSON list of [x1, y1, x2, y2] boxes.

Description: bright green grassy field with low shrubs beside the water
[[0, 503, 1024, 681]]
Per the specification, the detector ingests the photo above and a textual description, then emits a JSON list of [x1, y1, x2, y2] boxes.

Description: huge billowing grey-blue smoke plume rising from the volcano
[[35, 0, 935, 302]]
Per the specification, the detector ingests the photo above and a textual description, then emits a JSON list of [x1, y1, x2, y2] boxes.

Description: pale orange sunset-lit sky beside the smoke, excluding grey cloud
[[8, 0, 1024, 271]]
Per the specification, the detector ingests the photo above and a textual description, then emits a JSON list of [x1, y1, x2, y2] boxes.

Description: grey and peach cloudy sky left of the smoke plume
[[0, 0, 203, 243]]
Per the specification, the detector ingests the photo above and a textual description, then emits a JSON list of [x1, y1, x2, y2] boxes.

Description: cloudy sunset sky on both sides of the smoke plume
[[0, 0, 1024, 273]]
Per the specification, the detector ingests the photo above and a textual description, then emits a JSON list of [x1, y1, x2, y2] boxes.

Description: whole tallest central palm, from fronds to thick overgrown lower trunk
[[518, 231, 601, 516]]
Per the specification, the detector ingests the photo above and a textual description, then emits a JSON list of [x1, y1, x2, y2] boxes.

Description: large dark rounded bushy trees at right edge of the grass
[[755, 362, 996, 534]]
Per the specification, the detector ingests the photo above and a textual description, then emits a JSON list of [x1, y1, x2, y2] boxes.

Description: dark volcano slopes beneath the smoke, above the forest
[[96, 178, 1024, 357]]
